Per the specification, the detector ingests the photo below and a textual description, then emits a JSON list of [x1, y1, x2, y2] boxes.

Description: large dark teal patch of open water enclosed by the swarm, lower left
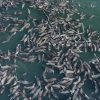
[[17, 61, 44, 82]]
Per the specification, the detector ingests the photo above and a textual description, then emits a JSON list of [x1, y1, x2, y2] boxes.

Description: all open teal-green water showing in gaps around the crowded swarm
[[0, 0, 100, 100]]
